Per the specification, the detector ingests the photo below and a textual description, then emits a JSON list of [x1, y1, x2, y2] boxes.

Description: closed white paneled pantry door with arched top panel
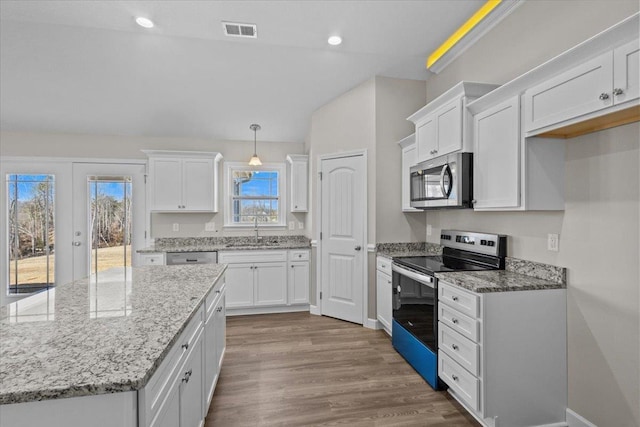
[[320, 155, 366, 324]]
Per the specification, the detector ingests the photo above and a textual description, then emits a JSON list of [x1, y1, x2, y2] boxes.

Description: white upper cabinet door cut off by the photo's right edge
[[613, 40, 640, 104]]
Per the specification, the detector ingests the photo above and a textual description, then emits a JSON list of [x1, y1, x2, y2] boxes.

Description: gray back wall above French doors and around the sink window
[[0, 132, 308, 238]]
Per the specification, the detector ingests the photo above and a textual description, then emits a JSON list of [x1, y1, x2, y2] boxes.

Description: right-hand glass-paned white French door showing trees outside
[[73, 163, 146, 280]]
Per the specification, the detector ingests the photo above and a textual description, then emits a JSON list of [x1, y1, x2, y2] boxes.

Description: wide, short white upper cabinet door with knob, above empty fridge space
[[524, 52, 613, 131]]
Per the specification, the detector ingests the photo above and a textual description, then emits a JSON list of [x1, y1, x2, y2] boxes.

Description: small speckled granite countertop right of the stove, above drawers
[[436, 270, 566, 293]]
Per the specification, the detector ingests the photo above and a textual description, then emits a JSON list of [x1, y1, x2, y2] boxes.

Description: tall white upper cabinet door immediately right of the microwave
[[473, 96, 520, 209]]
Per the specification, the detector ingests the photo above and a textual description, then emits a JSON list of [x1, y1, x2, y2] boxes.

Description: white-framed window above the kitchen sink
[[225, 163, 285, 226]]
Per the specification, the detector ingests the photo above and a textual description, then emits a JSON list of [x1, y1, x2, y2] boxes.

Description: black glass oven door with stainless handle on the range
[[392, 264, 438, 354]]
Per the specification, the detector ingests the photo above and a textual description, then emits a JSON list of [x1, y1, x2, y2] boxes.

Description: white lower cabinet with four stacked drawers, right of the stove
[[438, 279, 567, 427]]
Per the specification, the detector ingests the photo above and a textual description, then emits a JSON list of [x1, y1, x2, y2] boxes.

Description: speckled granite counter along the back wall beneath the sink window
[[138, 236, 311, 253]]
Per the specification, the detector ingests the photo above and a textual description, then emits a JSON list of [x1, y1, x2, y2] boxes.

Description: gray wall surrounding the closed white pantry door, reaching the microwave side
[[308, 77, 425, 319]]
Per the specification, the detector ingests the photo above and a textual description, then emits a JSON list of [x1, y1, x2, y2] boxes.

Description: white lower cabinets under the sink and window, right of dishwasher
[[219, 249, 310, 314]]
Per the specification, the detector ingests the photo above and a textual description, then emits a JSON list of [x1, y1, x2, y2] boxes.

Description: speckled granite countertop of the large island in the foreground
[[0, 264, 226, 404]]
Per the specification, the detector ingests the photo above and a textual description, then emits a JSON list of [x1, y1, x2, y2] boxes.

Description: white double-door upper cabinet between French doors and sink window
[[144, 151, 222, 212]]
